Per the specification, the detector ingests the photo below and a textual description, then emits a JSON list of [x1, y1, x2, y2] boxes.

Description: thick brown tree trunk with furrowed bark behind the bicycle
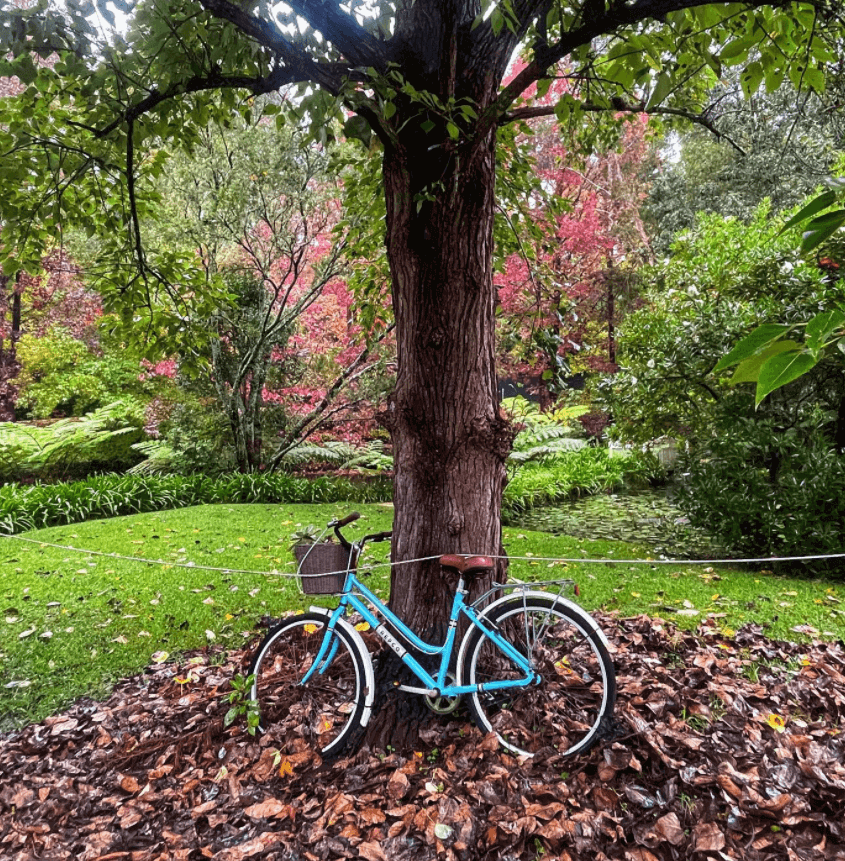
[[368, 102, 513, 747]]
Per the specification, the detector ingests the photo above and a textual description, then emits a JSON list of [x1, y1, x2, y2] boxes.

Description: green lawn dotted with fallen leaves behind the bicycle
[[0, 503, 845, 730]]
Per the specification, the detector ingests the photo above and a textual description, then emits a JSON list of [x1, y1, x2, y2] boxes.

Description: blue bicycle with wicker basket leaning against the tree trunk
[[249, 513, 616, 757]]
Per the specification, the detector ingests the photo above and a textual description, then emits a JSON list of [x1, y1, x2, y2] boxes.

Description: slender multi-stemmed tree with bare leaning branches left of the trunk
[[134, 118, 392, 472]]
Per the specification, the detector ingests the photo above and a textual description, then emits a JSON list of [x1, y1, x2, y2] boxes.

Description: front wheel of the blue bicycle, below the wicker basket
[[249, 613, 365, 757]]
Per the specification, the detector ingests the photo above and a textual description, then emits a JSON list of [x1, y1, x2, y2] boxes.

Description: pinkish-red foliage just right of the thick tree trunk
[[497, 65, 651, 396]]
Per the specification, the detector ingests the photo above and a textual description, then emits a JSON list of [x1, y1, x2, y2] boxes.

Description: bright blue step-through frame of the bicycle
[[301, 546, 539, 697]]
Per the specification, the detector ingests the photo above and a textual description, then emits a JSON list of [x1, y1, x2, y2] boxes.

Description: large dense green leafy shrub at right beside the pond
[[602, 197, 845, 555]]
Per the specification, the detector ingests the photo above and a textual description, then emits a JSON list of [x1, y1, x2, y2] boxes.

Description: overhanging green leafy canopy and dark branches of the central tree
[[0, 0, 841, 275]]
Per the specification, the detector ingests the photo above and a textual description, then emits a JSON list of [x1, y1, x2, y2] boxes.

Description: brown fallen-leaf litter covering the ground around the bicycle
[[0, 617, 845, 861]]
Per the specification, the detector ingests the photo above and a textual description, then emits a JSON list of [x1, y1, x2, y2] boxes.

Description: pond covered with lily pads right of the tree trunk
[[507, 487, 724, 559]]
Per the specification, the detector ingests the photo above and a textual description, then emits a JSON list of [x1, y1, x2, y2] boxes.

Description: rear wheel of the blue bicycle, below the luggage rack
[[461, 595, 616, 756]]
